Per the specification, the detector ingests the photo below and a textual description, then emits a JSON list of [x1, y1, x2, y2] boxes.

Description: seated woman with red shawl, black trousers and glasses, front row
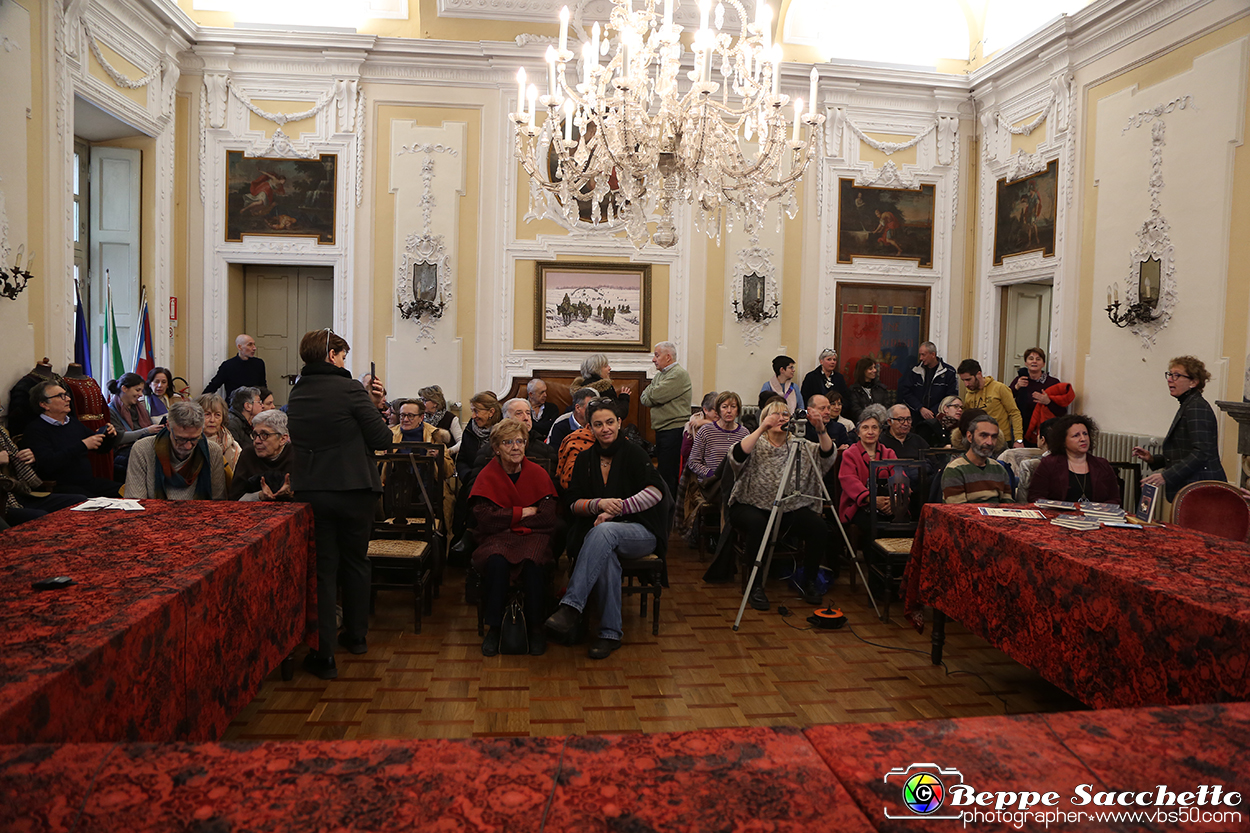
[[469, 422, 560, 657]]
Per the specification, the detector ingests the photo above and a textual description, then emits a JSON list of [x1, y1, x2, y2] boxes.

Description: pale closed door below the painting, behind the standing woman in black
[[244, 264, 334, 408]]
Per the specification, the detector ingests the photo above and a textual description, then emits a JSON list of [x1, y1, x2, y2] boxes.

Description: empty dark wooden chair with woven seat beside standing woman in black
[[369, 443, 443, 633]]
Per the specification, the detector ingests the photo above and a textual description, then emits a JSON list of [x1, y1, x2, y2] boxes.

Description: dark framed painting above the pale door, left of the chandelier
[[226, 150, 339, 245]]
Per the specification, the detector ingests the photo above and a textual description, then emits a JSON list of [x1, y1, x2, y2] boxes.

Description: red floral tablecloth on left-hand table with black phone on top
[[0, 500, 316, 743]]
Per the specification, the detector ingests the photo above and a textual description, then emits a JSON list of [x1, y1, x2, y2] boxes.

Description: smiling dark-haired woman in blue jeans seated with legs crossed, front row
[[546, 398, 669, 659]]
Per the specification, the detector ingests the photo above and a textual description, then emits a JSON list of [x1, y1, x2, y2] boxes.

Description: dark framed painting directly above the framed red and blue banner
[[838, 179, 935, 269]]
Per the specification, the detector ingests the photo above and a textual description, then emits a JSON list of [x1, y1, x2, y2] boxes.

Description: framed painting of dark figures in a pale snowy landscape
[[534, 261, 651, 353]]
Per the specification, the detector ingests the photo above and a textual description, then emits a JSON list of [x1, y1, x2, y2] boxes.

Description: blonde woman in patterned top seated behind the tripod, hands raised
[[704, 401, 838, 602]]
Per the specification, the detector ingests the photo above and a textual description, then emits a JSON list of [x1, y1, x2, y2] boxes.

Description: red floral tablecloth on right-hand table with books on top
[[905, 505, 1250, 708]]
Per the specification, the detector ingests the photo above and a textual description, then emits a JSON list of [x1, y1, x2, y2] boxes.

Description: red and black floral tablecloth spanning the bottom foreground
[[0, 704, 1250, 833]]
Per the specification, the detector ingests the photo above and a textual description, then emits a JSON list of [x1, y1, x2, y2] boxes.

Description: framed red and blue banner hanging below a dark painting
[[835, 284, 929, 395]]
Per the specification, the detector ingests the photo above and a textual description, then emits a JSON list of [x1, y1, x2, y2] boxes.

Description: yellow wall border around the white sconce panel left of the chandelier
[[366, 100, 483, 382]]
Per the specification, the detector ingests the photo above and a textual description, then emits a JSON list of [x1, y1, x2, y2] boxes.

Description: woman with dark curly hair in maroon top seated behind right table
[[1028, 414, 1120, 505]]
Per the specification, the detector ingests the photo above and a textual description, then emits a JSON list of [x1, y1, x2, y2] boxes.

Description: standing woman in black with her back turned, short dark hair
[[286, 329, 391, 679]]
